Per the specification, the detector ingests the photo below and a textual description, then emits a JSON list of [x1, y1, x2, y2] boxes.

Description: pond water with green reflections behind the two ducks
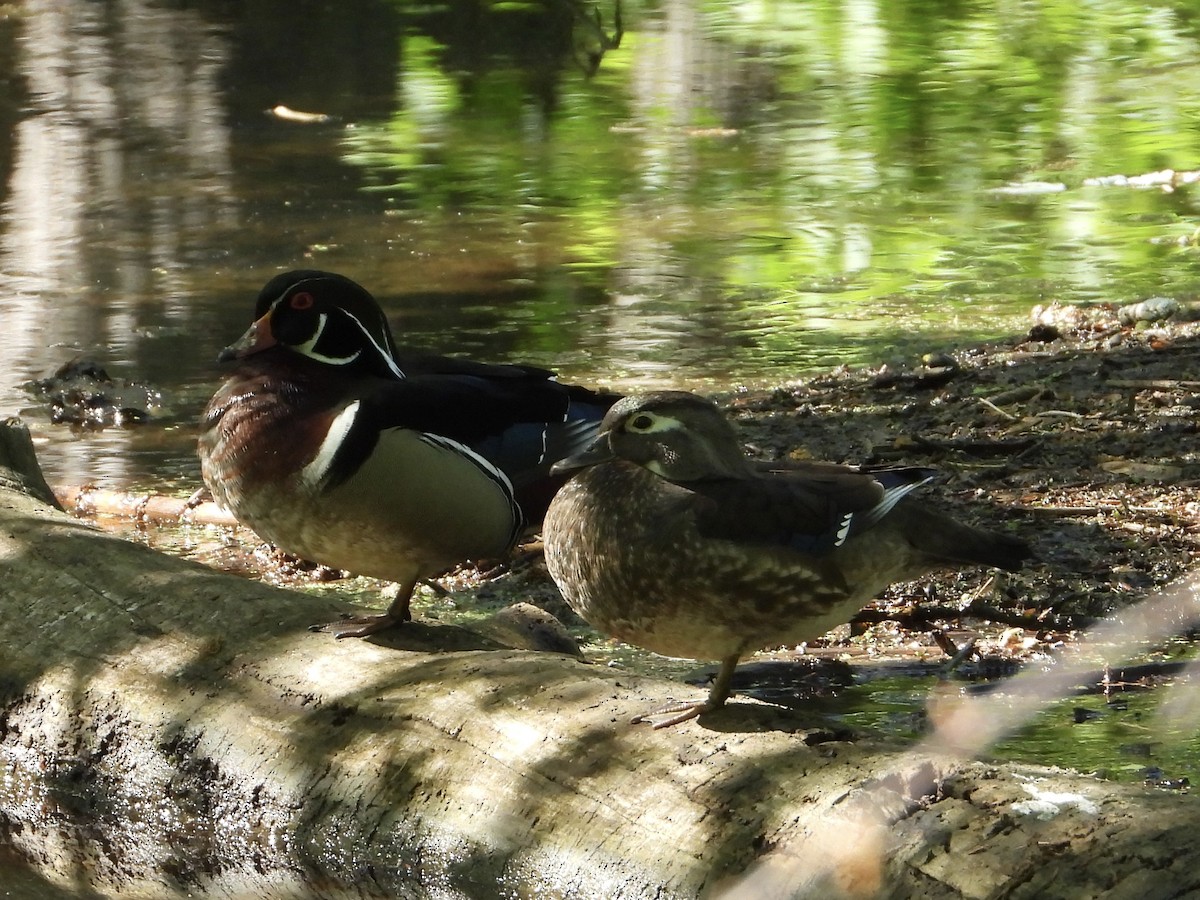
[[0, 0, 1200, 490]]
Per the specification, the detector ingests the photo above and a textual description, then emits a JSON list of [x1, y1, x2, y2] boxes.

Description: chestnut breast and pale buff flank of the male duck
[[200, 359, 520, 581]]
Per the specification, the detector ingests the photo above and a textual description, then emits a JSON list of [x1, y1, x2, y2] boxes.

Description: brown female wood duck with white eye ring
[[542, 391, 1030, 727]]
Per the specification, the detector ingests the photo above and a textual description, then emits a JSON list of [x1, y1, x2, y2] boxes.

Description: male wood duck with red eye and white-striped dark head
[[199, 270, 617, 637]]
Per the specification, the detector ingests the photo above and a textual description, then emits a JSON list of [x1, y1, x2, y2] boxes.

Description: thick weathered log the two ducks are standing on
[[0, 420, 1200, 898]]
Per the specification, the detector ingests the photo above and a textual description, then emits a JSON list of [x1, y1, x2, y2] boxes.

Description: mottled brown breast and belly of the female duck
[[544, 462, 862, 659]]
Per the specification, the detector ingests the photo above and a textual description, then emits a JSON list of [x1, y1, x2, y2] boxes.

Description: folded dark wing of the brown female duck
[[686, 463, 936, 556]]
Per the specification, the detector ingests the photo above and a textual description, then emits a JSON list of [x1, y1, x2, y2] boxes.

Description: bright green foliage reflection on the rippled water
[[344, 0, 1200, 378]]
